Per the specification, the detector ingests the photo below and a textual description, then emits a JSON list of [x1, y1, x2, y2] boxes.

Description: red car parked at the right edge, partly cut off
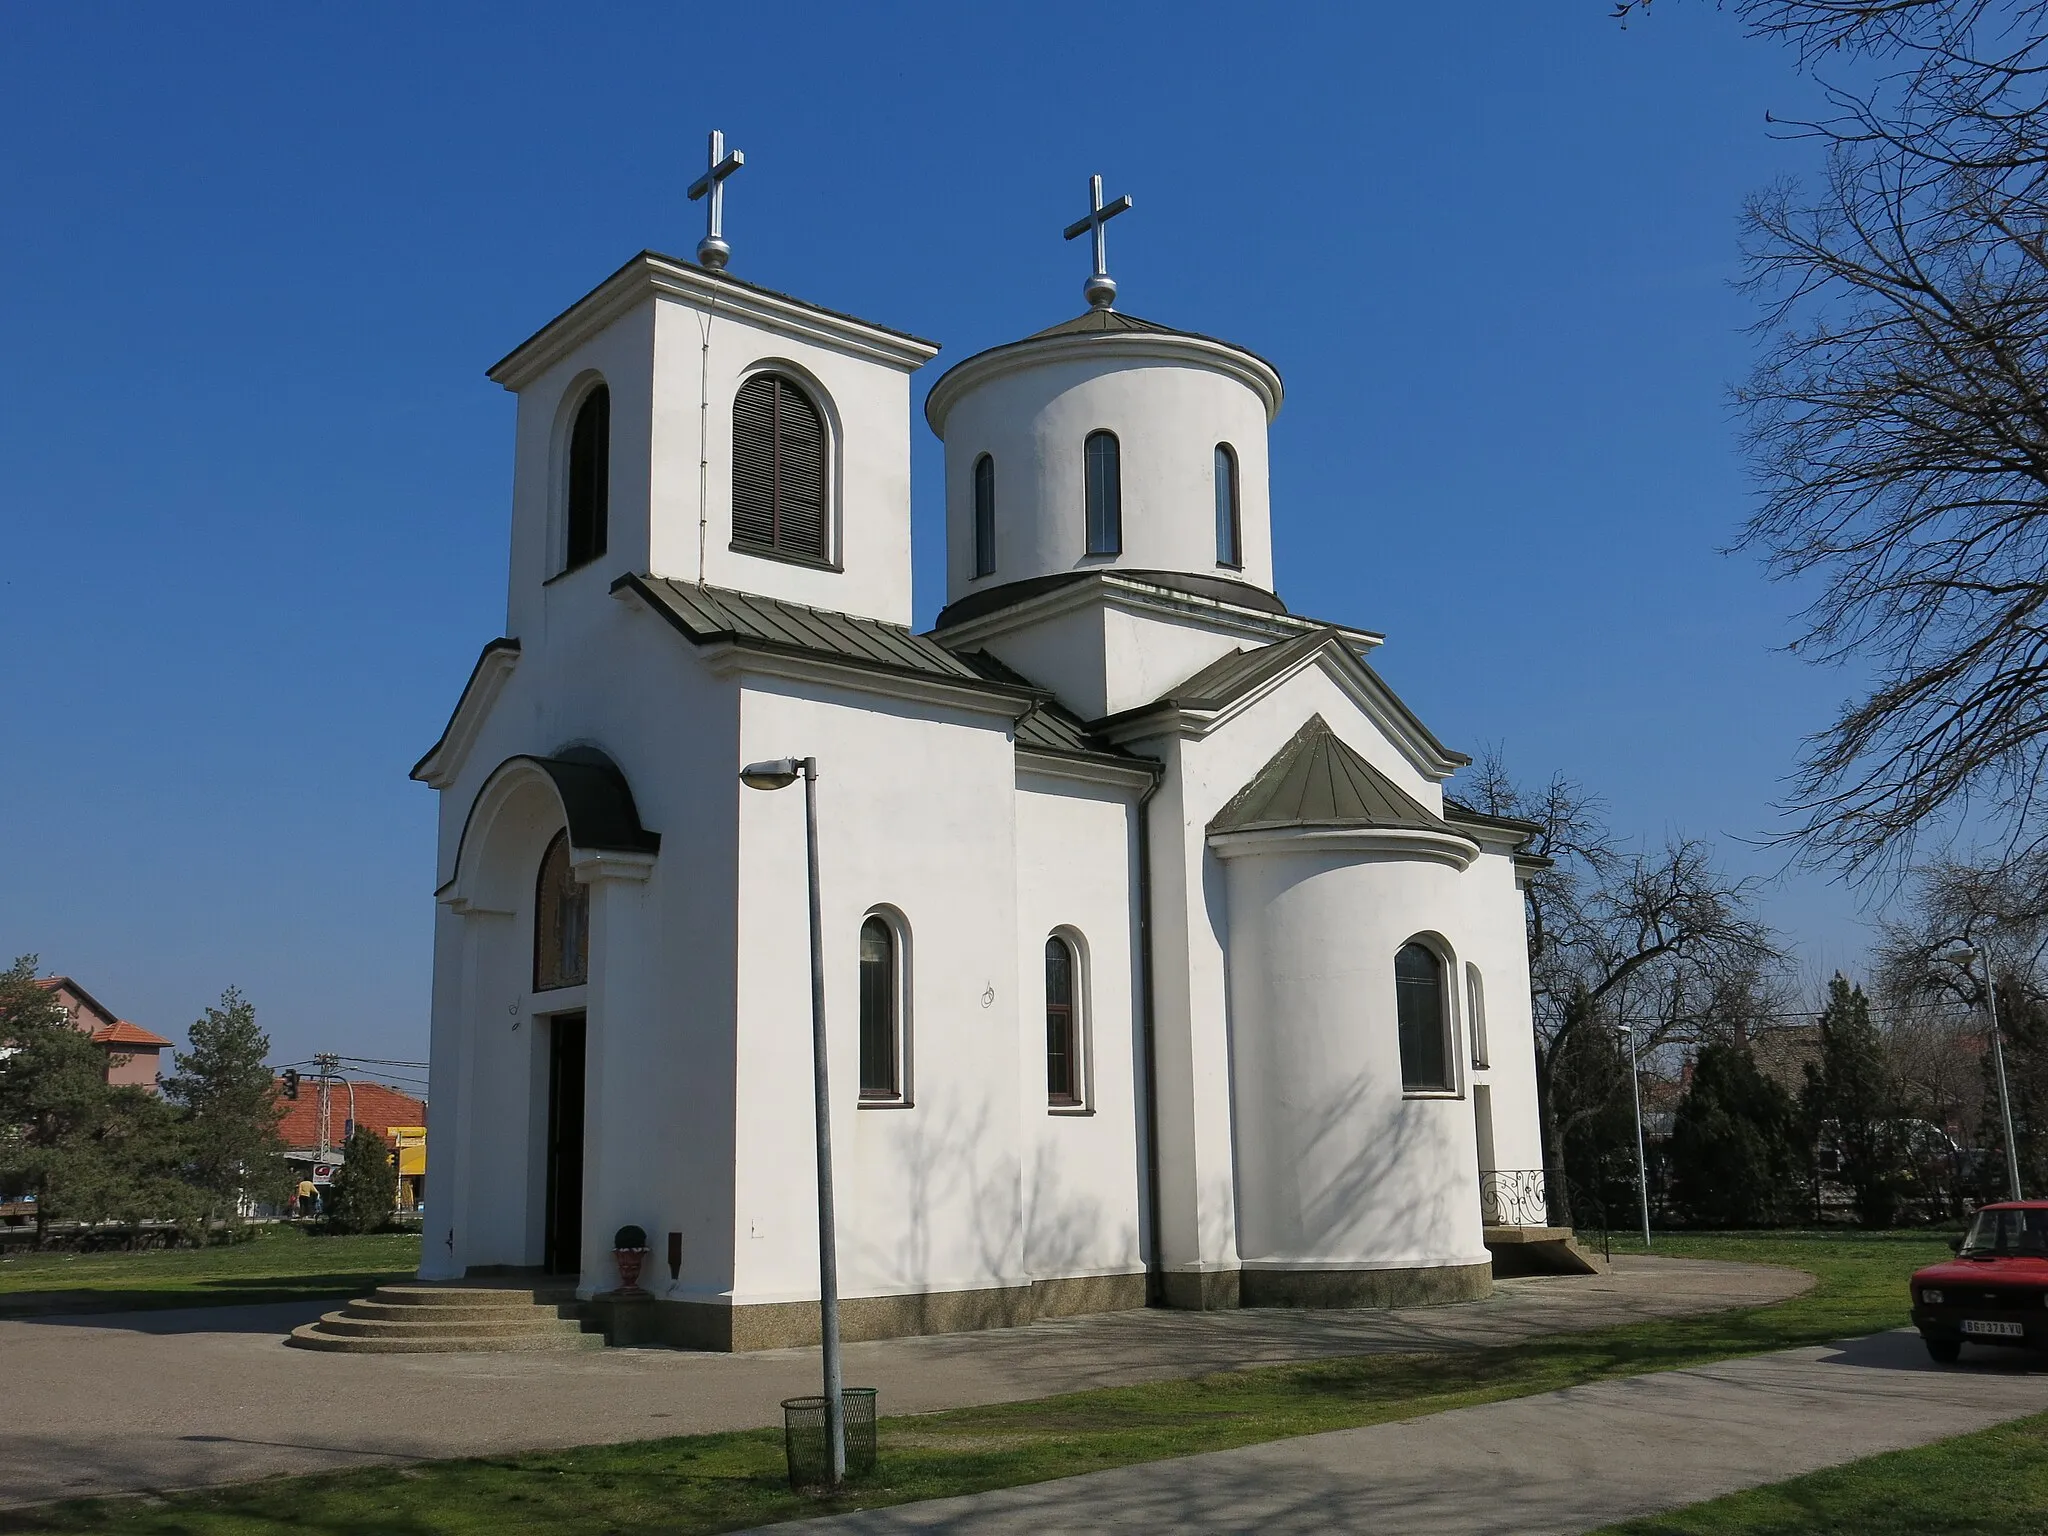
[[1913, 1200, 2048, 1364]]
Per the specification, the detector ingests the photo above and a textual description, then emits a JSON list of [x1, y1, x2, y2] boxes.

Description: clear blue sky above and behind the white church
[[0, 0, 1868, 1059]]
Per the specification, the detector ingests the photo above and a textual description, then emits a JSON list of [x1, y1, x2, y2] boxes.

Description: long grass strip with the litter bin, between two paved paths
[[0, 1233, 1948, 1536]]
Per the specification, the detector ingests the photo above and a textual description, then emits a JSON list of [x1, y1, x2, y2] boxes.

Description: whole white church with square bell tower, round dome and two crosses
[[414, 150, 1542, 1350]]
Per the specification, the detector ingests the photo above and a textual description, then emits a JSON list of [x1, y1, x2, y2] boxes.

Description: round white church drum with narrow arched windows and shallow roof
[[924, 307, 1282, 610]]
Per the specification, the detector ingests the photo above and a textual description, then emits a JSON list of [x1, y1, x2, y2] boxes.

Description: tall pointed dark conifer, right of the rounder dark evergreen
[[1800, 971, 1911, 1227]]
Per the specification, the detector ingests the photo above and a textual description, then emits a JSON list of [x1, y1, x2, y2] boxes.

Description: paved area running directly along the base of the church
[[0, 1257, 1808, 1505]]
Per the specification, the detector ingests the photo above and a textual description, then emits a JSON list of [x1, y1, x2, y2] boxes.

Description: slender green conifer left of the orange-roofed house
[[164, 987, 291, 1229]]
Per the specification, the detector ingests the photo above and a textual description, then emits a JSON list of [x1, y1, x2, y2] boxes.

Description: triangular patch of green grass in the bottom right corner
[[1602, 1413, 2048, 1536]]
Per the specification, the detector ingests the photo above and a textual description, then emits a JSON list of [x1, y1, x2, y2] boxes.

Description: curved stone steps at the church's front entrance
[[285, 1284, 604, 1354]]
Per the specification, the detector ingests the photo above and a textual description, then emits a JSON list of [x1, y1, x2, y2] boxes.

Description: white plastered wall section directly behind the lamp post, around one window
[[731, 676, 1024, 1305]]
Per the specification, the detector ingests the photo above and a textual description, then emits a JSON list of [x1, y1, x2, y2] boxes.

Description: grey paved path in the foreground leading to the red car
[[774, 1331, 2048, 1536]]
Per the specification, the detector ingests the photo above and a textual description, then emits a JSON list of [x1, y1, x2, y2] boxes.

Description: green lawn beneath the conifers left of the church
[[0, 1225, 420, 1317]]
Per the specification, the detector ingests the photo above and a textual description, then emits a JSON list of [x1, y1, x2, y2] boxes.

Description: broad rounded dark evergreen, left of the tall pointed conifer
[[1671, 1042, 1802, 1227]]
